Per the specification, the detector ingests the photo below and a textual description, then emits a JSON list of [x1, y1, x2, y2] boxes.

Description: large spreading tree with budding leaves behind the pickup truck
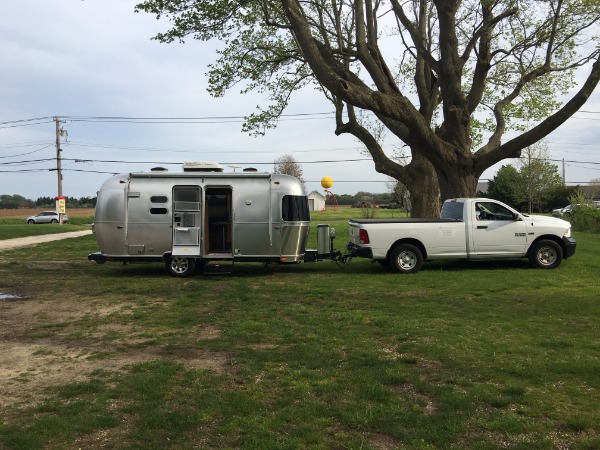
[[136, 0, 600, 216]]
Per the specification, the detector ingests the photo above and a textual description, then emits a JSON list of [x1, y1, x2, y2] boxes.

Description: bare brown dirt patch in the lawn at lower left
[[0, 298, 227, 407]]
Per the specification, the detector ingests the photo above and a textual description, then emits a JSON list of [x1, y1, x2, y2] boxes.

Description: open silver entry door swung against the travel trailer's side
[[172, 186, 202, 256]]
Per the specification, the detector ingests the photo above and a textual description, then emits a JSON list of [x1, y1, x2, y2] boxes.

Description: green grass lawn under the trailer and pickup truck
[[0, 214, 600, 449]]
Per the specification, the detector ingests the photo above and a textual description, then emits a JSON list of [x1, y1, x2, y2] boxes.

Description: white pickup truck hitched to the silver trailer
[[348, 198, 577, 273]]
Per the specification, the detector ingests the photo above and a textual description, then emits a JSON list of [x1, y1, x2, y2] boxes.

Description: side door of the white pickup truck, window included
[[470, 201, 527, 258]]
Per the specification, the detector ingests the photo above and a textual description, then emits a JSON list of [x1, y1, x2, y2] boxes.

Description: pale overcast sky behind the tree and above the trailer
[[0, 0, 600, 200]]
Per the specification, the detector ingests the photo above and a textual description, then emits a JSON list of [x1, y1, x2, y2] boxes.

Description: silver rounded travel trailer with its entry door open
[[88, 163, 342, 276]]
